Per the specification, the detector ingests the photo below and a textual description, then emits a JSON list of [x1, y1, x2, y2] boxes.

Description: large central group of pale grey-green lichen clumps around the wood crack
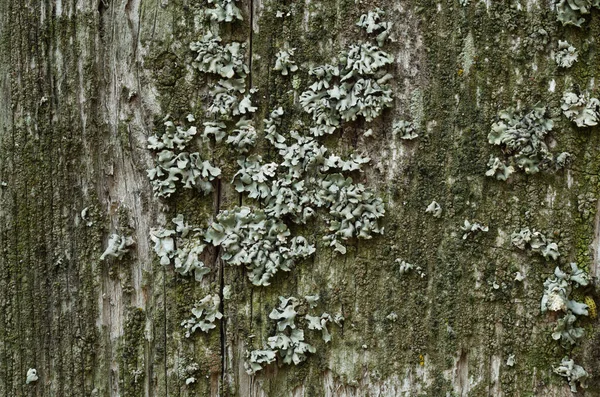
[[148, 5, 392, 374]]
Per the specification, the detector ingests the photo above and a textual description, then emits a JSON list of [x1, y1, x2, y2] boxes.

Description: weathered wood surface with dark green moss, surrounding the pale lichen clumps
[[0, 0, 600, 396]]
